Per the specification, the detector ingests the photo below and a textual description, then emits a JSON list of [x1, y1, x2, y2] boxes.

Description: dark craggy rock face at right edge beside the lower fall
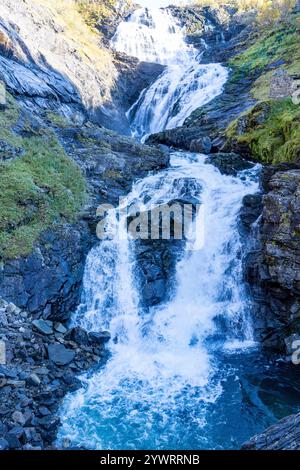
[[245, 169, 300, 352]]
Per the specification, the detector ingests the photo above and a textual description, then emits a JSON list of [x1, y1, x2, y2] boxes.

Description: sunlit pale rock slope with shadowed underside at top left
[[0, 0, 163, 134]]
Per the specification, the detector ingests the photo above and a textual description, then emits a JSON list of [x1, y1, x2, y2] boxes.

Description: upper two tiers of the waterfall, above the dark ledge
[[112, 8, 228, 137]]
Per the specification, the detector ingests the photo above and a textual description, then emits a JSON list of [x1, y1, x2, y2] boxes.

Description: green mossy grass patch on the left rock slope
[[0, 95, 86, 259]]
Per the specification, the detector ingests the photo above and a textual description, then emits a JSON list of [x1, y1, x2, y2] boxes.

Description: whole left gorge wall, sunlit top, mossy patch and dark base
[[0, 0, 168, 320]]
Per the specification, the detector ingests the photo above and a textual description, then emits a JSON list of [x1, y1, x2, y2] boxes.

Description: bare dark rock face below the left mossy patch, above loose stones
[[0, 224, 91, 320]]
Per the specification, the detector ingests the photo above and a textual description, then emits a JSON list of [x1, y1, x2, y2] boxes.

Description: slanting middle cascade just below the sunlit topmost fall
[[128, 62, 228, 136]]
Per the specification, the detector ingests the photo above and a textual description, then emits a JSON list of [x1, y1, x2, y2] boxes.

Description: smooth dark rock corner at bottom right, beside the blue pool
[[242, 414, 300, 450]]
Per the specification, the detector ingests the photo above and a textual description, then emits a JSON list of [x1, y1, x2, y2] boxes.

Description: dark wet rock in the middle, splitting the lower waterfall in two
[[129, 177, 201, 311]]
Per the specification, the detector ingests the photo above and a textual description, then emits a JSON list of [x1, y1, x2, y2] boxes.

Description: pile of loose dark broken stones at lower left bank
[[0, 299, 109, 450]]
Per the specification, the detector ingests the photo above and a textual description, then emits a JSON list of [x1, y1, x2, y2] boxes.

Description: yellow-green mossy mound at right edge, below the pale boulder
[[227, 99, 300, 163]]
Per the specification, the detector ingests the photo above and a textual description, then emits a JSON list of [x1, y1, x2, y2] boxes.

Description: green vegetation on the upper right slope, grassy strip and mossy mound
[[227, 7, 300, 164]]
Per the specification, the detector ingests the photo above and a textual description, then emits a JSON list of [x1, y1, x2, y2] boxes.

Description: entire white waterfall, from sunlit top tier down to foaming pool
[[59, 6, 258, 449]]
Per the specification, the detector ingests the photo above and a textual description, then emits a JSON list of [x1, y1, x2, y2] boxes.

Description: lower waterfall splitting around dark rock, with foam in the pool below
[[59, 153, 257, 449]]
